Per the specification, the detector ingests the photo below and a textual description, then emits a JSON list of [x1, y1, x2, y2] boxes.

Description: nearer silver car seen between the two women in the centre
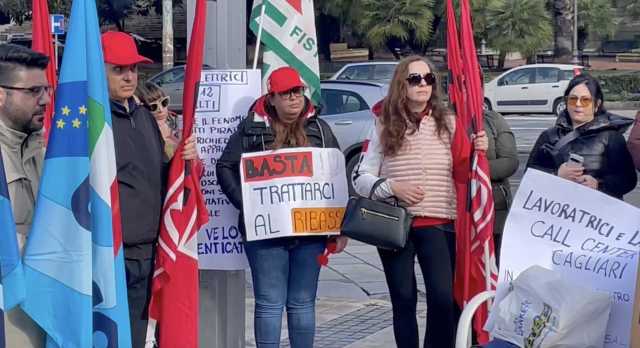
[[320, 80, 388, 194]]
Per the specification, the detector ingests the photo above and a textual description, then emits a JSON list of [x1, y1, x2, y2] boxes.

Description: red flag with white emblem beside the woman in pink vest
[[447, 0, 498, 343]]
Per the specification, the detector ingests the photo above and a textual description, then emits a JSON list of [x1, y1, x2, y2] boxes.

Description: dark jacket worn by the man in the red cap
[[111, 98, 168, 258]]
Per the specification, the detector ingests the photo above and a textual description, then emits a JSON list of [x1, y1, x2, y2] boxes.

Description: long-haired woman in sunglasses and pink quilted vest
[[353, 56, 488, 348]]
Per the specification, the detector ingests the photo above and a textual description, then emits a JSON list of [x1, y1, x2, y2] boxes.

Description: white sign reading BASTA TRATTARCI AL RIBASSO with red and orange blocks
[[240, 147, 349, 240]]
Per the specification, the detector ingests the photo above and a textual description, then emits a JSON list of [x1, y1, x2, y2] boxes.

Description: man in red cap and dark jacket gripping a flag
[[102, 31, 197, 348]]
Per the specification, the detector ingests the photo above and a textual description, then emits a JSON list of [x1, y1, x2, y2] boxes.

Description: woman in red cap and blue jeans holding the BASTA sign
[[216, 67, 346, 348]]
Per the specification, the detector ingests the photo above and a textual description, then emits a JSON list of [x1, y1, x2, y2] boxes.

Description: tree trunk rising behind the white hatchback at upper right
[[552, 0, 573, 63]]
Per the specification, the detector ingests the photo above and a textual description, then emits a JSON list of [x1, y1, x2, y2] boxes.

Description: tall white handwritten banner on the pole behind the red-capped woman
[[194, 70, 261, 270]]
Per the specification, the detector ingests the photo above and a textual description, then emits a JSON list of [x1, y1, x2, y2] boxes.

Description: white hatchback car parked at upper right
[[484, 64, 584, 115]]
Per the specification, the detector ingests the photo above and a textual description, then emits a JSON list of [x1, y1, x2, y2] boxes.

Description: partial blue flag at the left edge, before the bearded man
[[0, 151, 24, 348]]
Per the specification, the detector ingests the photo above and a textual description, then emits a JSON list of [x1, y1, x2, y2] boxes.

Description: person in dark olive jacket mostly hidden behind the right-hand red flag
[[484, 111, 518, 263]]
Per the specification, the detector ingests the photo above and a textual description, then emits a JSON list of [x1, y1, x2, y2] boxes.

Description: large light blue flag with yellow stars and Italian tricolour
[[22, 0, 131, 347]]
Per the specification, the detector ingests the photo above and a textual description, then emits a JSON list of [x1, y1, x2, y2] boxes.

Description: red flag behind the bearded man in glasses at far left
[[31, 0, 58, 142]]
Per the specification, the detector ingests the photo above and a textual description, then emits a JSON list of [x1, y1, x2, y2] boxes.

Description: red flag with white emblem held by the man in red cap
[[147, 0, 209, 348]]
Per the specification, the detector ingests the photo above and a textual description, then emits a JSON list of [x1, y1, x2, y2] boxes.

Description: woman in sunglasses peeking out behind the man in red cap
[[135, 82, 180, 156]]
